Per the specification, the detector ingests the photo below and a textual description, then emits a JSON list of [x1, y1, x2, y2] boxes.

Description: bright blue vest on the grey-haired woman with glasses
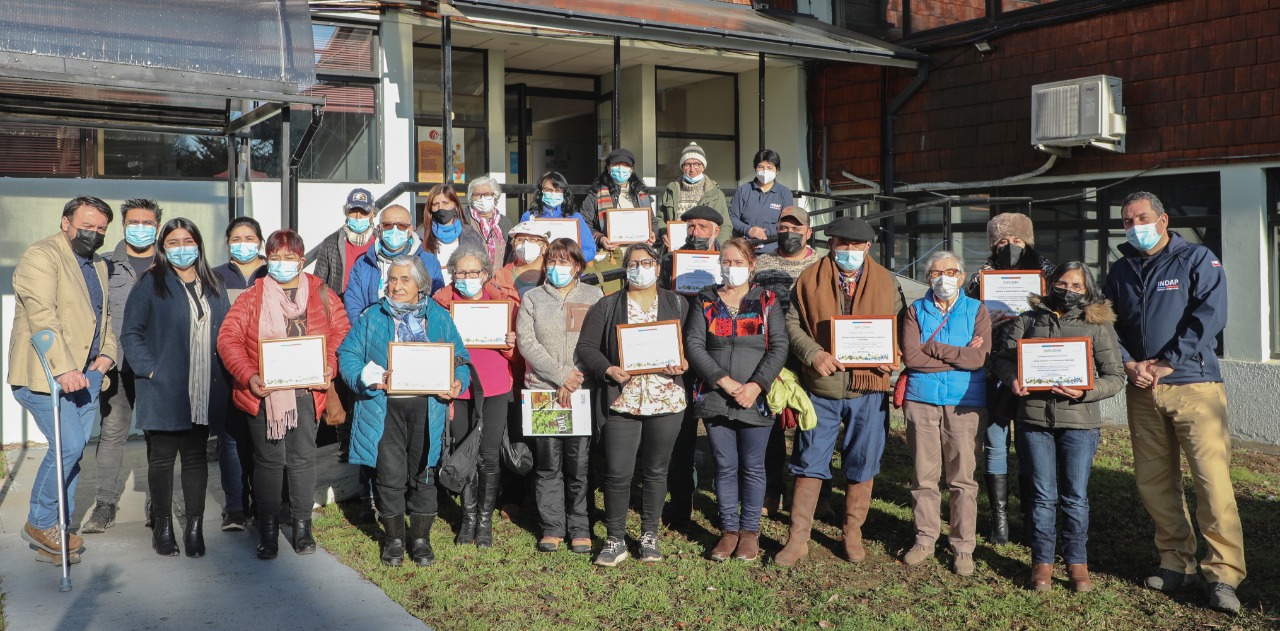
[[906, 292, 987, 407]]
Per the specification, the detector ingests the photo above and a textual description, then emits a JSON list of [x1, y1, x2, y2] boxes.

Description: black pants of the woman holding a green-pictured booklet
[[534, 436, 588, 539]]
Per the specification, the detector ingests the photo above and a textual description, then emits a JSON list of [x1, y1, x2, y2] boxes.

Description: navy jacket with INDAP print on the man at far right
[[1103, 232, 1226, 385]]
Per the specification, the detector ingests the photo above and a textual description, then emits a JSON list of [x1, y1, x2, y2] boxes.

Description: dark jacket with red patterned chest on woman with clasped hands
[[685, 285, 790, 425]]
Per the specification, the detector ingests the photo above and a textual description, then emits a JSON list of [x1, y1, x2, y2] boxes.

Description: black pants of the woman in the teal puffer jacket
[[375, 397, 440, 517]]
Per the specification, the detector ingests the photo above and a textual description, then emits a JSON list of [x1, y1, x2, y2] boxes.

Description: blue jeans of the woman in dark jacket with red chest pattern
[[703, 417, 773, 532]]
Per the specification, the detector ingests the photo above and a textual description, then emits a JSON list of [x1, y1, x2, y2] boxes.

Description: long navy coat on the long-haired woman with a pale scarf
[[120, 268, 231, 433]]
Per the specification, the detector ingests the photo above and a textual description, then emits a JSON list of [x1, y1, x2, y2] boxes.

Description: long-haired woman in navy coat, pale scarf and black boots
[[120, 218, 231, 557]]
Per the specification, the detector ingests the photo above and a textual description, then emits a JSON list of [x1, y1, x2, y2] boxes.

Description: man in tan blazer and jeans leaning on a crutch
[[8, 197, 116, 570]]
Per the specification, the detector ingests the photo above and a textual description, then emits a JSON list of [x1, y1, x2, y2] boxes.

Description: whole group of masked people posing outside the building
[[9, 145, 1244, 611]]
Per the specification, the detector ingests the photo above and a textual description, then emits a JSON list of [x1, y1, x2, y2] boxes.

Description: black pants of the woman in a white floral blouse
[[603, 411, 685, 538]]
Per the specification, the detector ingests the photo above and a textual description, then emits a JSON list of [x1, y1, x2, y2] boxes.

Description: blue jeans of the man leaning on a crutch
[[13, 371, 102, 530]]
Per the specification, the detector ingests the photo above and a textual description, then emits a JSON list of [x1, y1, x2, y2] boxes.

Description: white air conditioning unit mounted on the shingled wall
[[1032, 74, 1125, 157]]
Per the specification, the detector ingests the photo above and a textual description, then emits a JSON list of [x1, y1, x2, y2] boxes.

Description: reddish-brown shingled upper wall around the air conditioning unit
[[810, 0, 1280, 186]]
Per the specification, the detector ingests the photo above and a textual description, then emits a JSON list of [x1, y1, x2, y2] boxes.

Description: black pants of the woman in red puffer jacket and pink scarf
[[248, 390, 319, 520]]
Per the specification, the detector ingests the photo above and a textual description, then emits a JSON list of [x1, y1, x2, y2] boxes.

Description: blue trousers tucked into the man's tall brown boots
[[788, 392, 888, 484]]
